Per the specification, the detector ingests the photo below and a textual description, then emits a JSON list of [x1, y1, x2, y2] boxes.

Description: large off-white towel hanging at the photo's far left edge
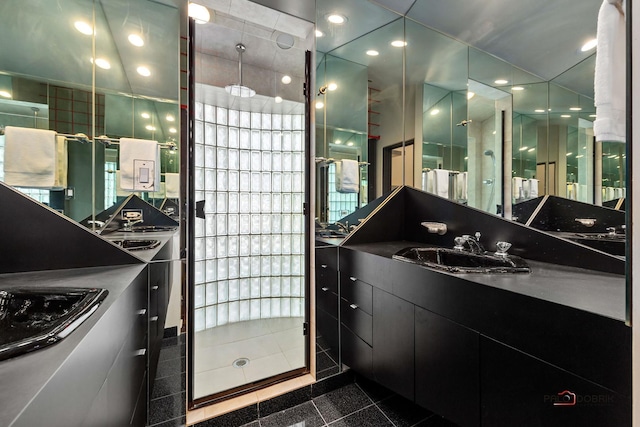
[[4, 126, 56, 188]]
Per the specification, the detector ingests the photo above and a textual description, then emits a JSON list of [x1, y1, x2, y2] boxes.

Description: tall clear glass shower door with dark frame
[[188, 4, 313, 408]]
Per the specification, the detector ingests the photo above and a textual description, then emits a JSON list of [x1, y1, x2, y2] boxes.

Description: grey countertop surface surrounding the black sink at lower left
[[0, 264, 146, 426]]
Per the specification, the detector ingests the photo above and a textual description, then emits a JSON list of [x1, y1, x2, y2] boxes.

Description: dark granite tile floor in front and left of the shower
[[149, 335, 456, 427]]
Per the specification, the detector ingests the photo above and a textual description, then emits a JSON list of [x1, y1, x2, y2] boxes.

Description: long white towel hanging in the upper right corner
[[593, 0, 626, 142]]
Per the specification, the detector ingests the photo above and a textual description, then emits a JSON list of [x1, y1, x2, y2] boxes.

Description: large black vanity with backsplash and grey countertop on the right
[[316, 187, 631, 427]]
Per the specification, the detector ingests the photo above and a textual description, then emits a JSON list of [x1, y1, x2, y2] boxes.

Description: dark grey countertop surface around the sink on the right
[[345, 241, 626, 321]]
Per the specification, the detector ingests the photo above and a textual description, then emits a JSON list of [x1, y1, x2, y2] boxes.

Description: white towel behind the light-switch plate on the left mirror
[[120, 138, 160, 192]]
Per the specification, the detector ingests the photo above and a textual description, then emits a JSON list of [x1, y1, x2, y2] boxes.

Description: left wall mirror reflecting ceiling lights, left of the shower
[[0, 0, 180, 244]]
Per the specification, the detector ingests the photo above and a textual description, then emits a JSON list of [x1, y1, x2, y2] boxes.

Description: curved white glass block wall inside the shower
[[194, 103, 305, 331]]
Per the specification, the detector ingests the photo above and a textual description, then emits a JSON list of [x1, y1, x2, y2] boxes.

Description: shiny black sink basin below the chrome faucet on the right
[[393, 248, 531, 274]]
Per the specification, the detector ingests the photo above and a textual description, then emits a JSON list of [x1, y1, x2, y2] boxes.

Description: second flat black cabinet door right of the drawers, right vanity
[[415, 307, 480, 426]]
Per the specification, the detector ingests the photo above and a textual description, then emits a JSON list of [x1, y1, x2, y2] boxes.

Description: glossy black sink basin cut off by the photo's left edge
[[0, 287, 109, 360]]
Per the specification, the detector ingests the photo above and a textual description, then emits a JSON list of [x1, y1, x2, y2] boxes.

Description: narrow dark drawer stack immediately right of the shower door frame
[[315, 246, 340, 362]]
